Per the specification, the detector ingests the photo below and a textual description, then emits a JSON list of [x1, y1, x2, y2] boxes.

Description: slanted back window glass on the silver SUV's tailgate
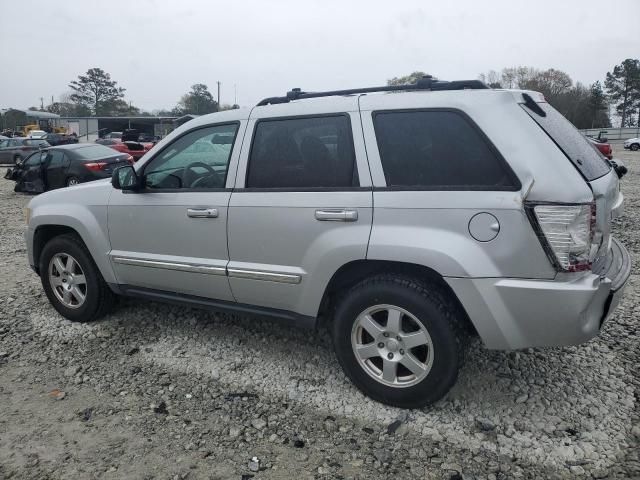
[[521, 102, 611, 181]]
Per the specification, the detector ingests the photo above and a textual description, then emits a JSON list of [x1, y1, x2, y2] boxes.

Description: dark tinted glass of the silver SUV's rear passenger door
[[246, 115, 358, 188]]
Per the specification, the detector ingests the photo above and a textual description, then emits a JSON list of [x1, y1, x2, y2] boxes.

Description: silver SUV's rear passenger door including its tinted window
[[228, 97, 372, 316]]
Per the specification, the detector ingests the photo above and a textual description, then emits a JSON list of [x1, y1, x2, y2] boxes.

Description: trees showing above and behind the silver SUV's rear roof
[[387, 58, 640, 128]]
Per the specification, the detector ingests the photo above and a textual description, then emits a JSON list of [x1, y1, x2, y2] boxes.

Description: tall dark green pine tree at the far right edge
[[604, 58, 640, 127]]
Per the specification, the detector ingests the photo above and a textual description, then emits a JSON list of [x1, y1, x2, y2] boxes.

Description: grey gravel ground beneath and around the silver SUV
[[0, 144, 640, 480]]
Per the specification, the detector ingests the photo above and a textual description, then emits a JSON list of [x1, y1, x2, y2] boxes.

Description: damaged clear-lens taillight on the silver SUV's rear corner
[[527, 202, 598, 272]]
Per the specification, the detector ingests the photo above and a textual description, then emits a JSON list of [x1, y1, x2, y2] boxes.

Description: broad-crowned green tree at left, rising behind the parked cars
[[69, 68, 125, 115]]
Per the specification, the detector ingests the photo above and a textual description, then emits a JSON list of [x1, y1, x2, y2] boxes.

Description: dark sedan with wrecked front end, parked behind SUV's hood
[[5, 143, 133, 193]]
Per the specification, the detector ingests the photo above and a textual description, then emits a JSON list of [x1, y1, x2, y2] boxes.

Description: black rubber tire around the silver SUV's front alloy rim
[[39, 234, 116, 322]]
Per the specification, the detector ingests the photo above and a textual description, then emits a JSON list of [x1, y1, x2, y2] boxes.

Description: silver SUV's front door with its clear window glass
[[108, 122, 244, 301]]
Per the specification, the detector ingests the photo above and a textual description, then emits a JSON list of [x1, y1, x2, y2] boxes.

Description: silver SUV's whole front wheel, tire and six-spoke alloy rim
[[39, 234, 115, 322]]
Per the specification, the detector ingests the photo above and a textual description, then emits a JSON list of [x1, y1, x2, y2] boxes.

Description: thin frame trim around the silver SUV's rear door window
[[242, 112, 362, 192]]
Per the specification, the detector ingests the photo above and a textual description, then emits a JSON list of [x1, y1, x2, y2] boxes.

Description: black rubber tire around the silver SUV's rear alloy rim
[[332, 274, 466, 408]]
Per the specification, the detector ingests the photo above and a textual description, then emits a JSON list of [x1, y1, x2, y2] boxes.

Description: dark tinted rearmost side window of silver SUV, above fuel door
[[373, 110, 520, 191]]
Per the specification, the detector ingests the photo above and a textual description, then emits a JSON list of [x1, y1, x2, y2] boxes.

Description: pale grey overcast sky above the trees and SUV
[[0, 0, 640, 110]]
